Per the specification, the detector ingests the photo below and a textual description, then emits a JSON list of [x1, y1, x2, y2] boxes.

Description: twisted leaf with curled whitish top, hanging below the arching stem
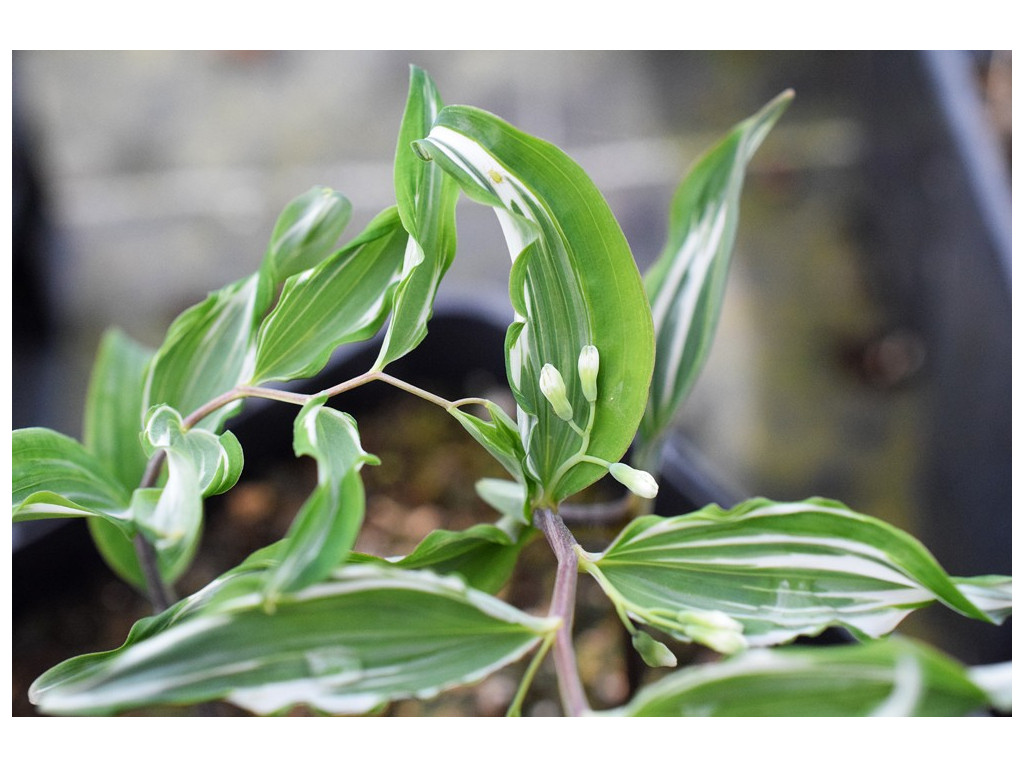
[[265, 398, 380, 606]]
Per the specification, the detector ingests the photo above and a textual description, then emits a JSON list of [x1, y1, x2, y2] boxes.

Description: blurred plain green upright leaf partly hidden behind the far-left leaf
[[83, 329, 154, 588]]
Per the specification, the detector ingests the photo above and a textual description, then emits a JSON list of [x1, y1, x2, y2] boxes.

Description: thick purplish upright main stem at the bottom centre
[[534, 507, 590, 717]]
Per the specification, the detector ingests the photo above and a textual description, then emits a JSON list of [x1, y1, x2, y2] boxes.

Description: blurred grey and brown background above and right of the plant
[[13, 51, 1011, 684]]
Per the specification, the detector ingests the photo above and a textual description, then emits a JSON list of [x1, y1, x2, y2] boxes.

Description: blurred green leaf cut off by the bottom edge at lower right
[[618, 638, 1000, 717]]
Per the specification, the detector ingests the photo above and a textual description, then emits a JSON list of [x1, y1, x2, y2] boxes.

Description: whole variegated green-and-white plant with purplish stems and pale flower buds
[[12, 68, 1011, 716]]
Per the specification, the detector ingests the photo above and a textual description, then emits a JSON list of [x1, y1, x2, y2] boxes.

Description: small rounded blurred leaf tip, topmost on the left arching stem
[[260, 186, 352, 284]]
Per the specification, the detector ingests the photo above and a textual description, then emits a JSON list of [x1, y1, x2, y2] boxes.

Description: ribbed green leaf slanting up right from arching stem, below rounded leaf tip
[[252, 207, 409, 382]]
